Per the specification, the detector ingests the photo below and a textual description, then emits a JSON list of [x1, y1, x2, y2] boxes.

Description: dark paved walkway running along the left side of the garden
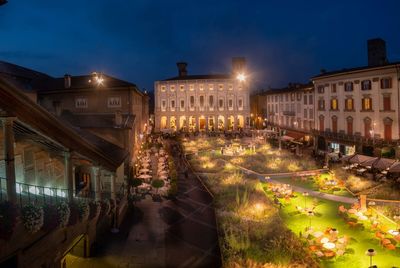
[[67, 141, 221, 268]]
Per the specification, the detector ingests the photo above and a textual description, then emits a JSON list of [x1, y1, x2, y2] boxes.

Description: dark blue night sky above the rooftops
[[0, 0, 400, 89]]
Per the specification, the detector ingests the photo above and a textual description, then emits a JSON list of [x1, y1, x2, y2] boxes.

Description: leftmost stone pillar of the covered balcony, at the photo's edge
[[2, 117, 17, 203]]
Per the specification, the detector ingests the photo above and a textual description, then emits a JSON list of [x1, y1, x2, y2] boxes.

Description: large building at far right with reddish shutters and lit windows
[[312, 63, 400, 154]]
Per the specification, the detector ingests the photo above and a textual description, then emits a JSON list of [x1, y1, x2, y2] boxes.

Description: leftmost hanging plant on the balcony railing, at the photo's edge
[[0, 201, 18, 240]]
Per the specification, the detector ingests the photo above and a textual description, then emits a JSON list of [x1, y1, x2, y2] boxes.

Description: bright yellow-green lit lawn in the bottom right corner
[[264, 187, 400, 268]]
